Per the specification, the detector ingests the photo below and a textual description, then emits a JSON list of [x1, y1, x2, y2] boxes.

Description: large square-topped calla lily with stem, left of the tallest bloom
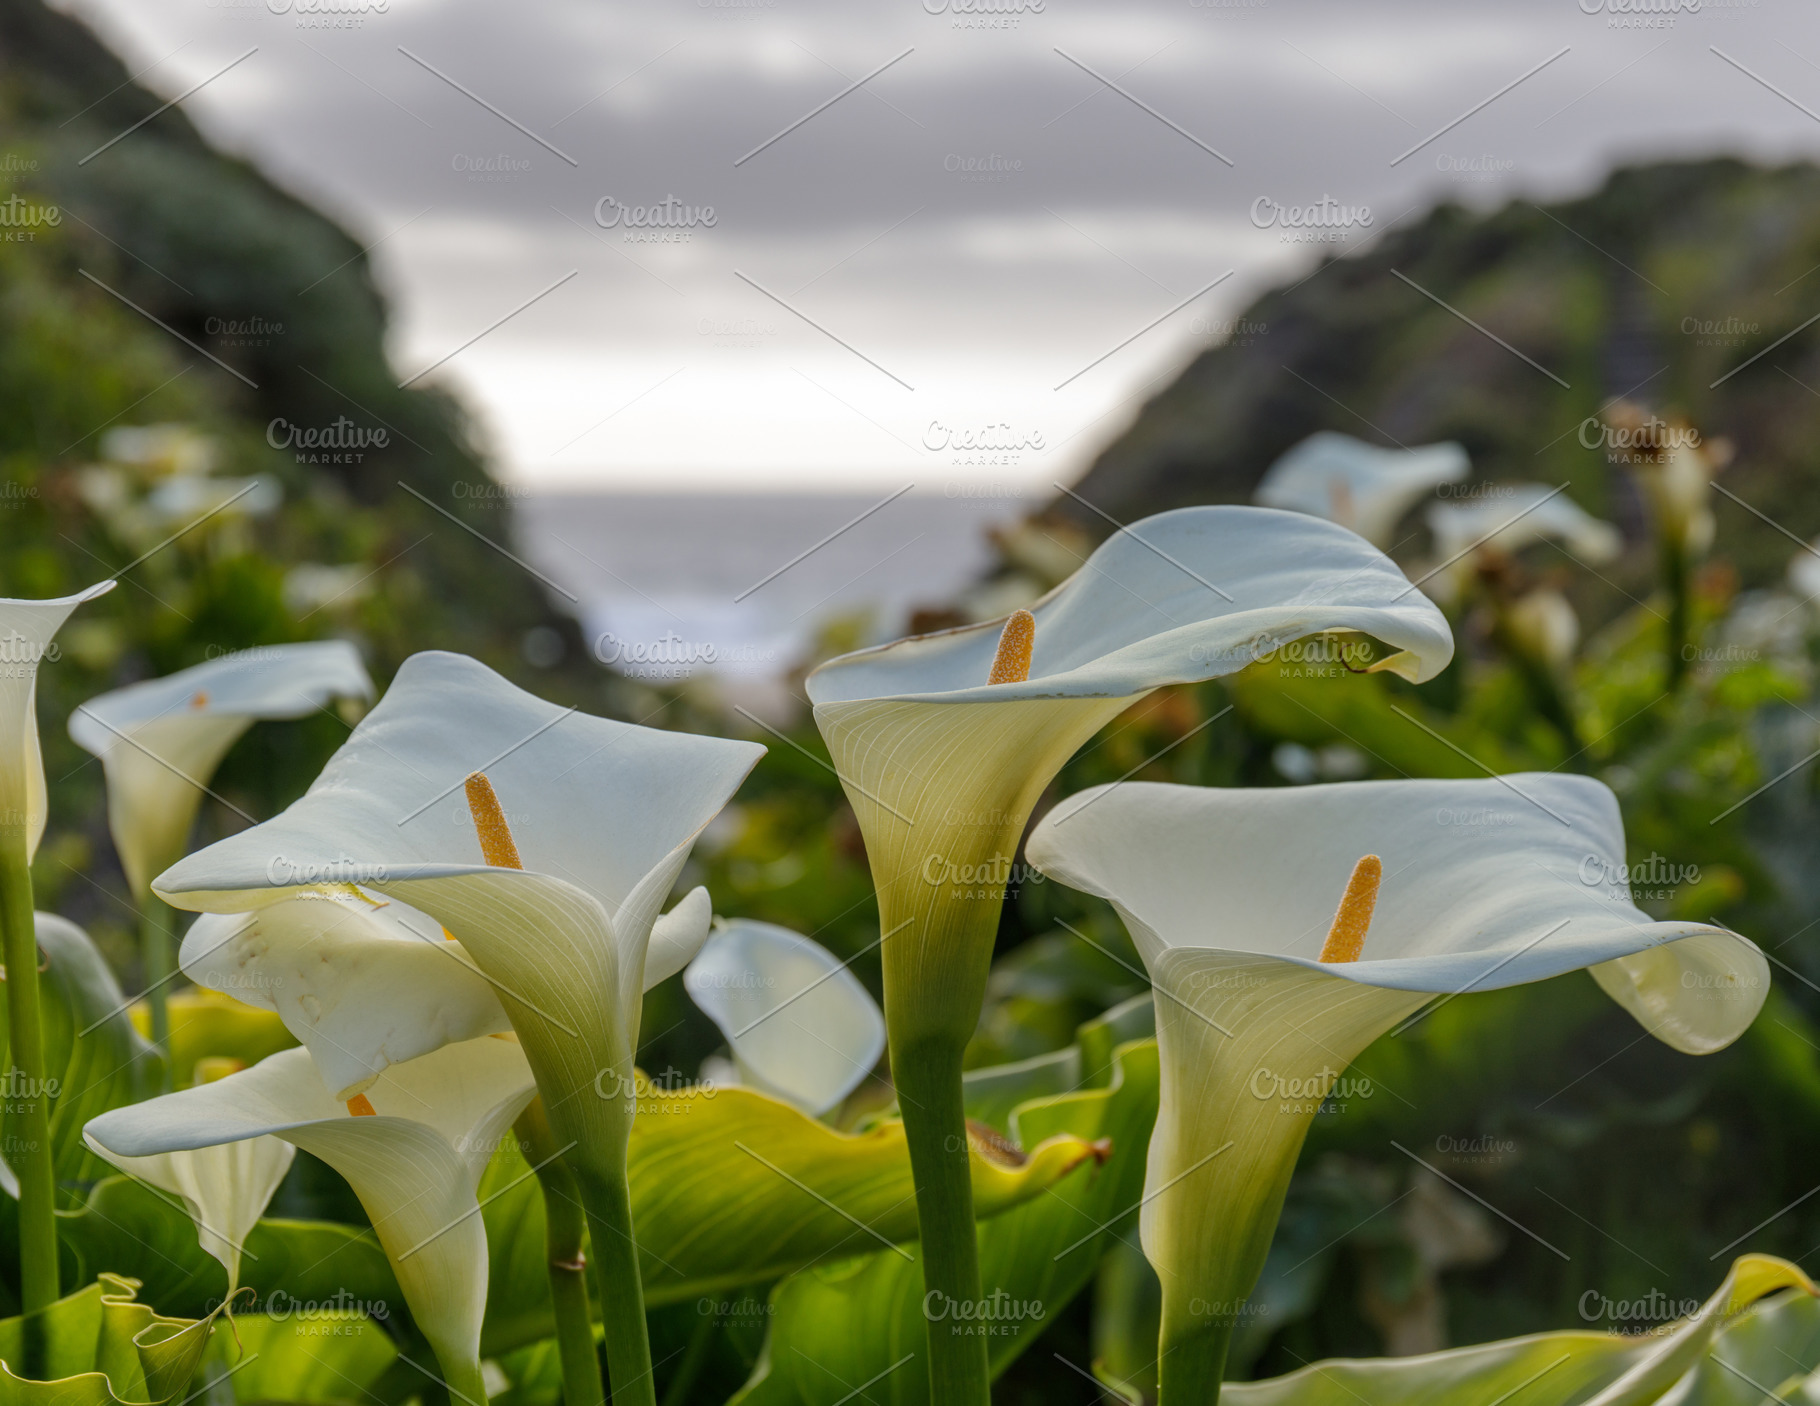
[[155, 653, 764, 1401]]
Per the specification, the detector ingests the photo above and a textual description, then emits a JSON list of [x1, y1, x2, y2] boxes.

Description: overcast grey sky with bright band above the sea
[[56, 0, 1820, 491]]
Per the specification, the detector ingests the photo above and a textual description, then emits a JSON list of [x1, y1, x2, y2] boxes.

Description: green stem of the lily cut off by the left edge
[[0, 826, 56, 1319]]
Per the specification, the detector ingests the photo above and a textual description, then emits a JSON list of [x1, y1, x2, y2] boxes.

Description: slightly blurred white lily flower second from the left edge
[[69, 640, 373, 900]]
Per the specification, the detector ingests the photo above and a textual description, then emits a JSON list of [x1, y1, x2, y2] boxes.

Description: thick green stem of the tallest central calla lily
[[892, 1039, 992, 1406]]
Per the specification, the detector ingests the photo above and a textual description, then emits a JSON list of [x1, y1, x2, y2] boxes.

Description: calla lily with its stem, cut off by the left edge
[[0, 580, 113, 1317]]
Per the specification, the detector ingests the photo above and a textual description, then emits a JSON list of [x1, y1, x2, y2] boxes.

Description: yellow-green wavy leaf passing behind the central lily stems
[[465, 1086, 1097, 1355]]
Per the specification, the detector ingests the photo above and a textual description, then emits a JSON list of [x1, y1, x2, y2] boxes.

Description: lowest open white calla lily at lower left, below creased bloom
[[84, 1039, 537, 1402]]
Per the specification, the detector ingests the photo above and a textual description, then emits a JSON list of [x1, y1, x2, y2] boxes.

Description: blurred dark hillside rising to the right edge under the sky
[[1057, 160, 1820, 584]]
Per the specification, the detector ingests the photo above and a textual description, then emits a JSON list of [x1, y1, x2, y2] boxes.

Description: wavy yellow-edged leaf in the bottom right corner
[[1219, 1255, 1815, 1406]]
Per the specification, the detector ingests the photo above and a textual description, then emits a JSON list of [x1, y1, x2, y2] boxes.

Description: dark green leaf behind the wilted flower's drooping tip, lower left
[[58, 1175, 404, 1317]]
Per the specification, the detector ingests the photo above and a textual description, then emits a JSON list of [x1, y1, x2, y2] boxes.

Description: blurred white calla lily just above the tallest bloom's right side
[[1252, 429, 1472, 547]]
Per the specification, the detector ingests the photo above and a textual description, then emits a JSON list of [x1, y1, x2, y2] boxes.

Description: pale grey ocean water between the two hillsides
[[515, 489, 1037, 680]]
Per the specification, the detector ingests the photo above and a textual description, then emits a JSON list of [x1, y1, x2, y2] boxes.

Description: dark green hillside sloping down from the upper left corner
[[0, 0, 612, 940]]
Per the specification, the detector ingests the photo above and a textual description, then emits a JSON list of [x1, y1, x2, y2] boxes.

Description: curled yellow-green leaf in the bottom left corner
[[0, 1275, 215, 1406]]
